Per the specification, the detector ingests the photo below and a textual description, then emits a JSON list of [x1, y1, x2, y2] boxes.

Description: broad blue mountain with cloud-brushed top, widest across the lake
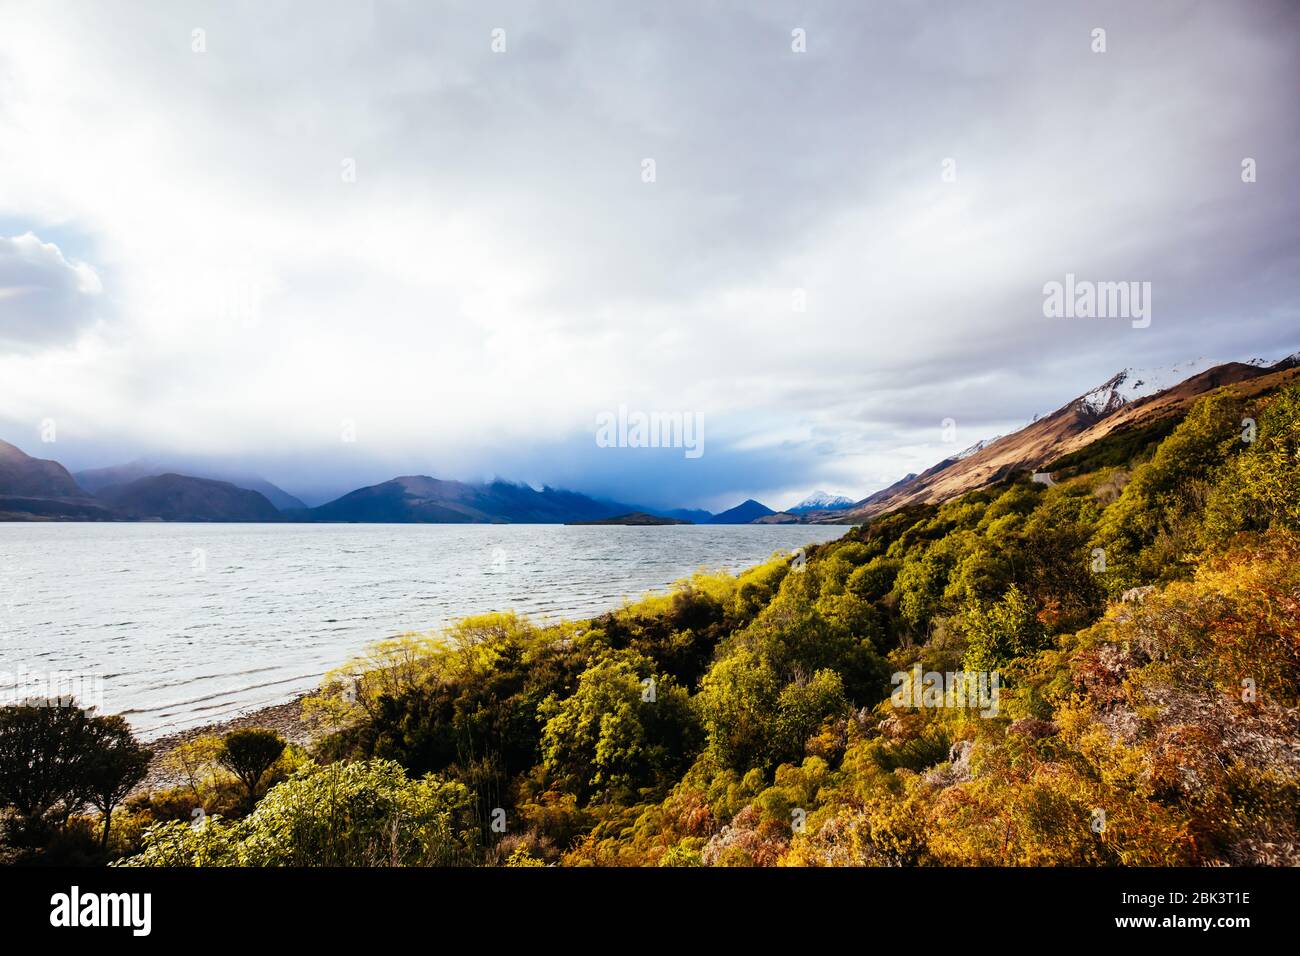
[[308, 475, 636, 524]]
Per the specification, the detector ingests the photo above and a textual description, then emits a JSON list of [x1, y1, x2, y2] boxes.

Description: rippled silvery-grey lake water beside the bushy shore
[[0, 523, 848, 737]]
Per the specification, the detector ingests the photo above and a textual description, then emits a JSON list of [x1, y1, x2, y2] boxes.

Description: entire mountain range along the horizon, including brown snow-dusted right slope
[[0, 354, 1300, 524]]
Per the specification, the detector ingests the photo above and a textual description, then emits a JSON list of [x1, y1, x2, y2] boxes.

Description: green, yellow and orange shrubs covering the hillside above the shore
[[5, 386, 1300, 866]]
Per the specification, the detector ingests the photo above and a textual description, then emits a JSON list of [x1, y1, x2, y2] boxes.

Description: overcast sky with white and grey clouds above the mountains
[[0, 0, 1300, 509]]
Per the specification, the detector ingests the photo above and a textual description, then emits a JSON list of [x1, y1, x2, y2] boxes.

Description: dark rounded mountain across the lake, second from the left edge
[[100, 475, 283, 522]]
